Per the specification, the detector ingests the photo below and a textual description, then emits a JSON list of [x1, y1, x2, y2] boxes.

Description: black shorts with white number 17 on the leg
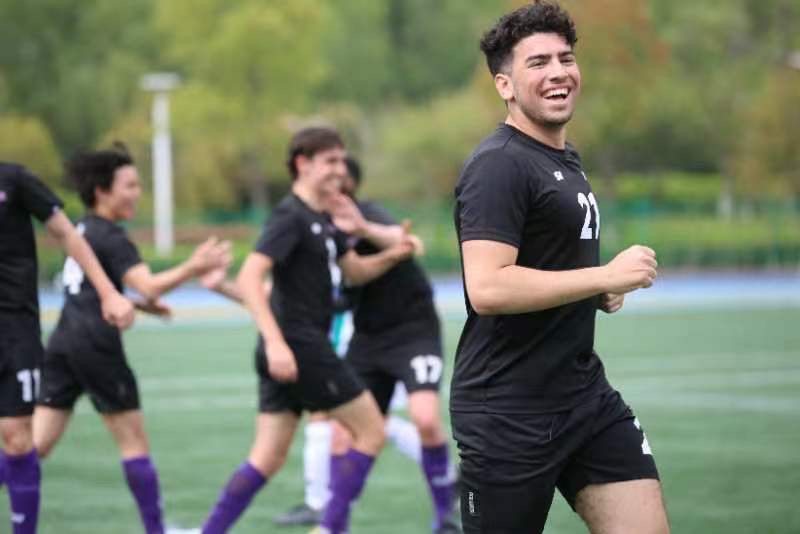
[[345, 321, 444, 414]]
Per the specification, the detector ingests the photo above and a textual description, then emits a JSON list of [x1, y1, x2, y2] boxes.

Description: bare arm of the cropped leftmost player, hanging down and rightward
[[45, 210, 135, 329]]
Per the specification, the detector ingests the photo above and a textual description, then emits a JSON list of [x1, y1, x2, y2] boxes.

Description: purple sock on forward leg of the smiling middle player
[[322, 449, 375, 534]]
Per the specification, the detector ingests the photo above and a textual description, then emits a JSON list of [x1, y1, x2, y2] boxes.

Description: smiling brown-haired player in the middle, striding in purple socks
[[198, 128, 413, 534]]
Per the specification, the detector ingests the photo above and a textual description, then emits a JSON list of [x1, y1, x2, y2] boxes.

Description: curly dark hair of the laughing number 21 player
[[481, 0, 578, 76]]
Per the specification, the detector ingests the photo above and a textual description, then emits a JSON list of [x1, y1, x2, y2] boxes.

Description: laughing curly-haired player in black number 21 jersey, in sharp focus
[[450, 1, 669, 534]]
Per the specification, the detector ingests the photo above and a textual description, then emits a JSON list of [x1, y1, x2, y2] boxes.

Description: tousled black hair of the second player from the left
[[66, 141, 133, 208]]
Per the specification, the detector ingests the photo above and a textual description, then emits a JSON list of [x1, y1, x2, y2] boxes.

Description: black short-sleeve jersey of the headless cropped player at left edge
[[0, 163, 62, 317]]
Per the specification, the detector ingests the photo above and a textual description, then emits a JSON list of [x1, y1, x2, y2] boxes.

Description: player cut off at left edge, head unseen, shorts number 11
[[0, 163, 134, 534]]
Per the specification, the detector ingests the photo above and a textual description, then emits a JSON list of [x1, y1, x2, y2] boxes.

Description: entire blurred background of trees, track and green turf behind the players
[[0, 0, 800, 534]]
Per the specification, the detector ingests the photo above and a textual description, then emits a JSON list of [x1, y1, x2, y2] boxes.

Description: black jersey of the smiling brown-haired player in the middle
[[255, 194, 348, 338]]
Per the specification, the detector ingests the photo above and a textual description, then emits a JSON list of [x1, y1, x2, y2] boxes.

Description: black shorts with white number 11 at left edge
[[0, 313, 44, 417]]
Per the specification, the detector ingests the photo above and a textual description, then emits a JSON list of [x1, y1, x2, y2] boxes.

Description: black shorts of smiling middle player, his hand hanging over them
[[255, 335, 365, 415]]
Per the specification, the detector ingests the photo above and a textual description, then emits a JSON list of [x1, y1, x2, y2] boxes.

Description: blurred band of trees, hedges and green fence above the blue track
[[0, 0, 800, 277]]
